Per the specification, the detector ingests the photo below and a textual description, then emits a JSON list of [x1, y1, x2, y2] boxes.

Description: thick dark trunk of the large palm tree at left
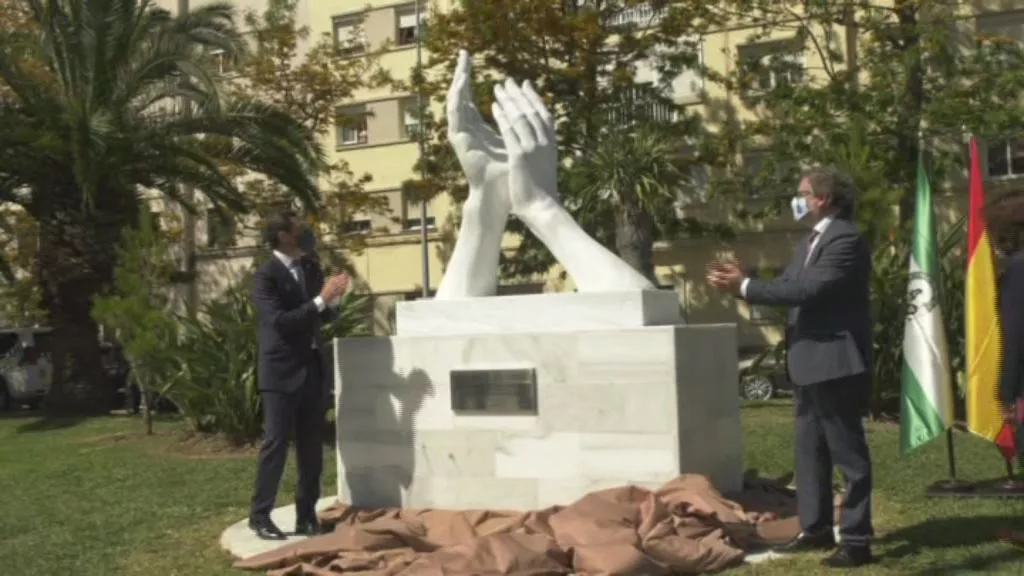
[[33, 190, 137, 416]]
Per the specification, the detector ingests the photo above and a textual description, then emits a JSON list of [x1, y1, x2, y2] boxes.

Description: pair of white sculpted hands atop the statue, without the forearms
[[447, 51, 558, 237]]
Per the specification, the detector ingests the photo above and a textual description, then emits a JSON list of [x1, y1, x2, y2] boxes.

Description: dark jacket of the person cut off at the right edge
[[999, 251, 1024, 408]]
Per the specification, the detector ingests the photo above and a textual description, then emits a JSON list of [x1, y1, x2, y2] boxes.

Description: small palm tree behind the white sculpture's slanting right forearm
[[571, 123, 686, 285]]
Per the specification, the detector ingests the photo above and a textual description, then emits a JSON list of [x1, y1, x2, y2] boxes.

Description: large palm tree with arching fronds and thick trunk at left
[[0, 0, 324, 413]]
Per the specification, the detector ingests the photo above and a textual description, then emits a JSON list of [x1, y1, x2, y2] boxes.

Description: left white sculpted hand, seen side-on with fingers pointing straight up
[[447, 50, 510, 219]]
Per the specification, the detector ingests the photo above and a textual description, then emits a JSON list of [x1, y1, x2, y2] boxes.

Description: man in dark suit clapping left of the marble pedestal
[[249, 211, 348, 540]]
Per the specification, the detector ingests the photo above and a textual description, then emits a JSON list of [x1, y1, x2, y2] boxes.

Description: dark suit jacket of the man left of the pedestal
[[253, 256, 332, 393]]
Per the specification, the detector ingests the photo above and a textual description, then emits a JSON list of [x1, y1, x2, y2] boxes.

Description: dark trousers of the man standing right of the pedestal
[[795, 376, 873, 545]]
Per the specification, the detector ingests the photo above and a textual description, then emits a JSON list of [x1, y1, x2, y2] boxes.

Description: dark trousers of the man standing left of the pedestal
[[250, 355, 326, 522]]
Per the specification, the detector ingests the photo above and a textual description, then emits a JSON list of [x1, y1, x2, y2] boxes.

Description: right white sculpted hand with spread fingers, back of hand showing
[[493, 80, 558, 216]]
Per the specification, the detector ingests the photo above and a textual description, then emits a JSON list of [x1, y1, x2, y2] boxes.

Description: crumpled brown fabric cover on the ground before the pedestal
[[234, 475, 800, 576]]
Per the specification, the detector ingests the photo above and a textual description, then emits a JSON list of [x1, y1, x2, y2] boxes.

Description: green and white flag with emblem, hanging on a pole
[[900, 152, 953, 454]]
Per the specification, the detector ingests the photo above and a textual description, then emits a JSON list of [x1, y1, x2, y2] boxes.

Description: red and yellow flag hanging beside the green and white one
[[964, 139, 1004, 442]]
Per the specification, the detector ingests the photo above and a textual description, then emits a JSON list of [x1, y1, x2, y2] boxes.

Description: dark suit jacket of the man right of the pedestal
[[745, 218, 871, 385]]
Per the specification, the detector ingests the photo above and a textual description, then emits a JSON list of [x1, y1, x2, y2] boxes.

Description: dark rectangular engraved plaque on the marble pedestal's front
[[451, 368, 537, 416]]
